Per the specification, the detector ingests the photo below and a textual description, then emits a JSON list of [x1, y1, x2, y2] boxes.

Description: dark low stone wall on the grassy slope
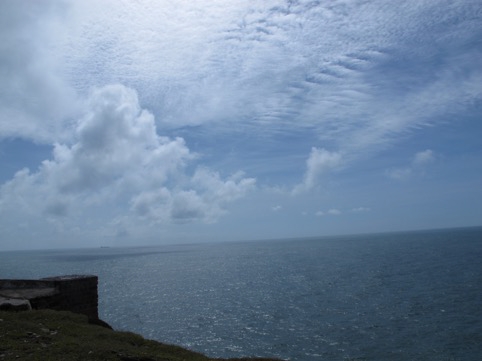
[[0, 275, 99, 320]]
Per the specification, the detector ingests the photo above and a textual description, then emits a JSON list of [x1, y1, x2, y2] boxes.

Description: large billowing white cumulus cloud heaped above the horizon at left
[[0, 84, 256, 240]]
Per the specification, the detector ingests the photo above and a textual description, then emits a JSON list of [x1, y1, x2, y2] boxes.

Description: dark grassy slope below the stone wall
[[0, 310, 282, 361]]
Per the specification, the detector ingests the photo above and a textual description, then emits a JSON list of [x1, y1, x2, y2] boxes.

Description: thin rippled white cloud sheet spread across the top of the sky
[[0, 0, 482, 157]]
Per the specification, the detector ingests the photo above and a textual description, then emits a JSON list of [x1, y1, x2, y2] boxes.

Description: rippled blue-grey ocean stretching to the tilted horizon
[[0, 227, 482, 361]]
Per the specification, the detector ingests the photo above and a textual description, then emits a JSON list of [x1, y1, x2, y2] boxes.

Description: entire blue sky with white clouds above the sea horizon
[[0, 0, 482, 250]]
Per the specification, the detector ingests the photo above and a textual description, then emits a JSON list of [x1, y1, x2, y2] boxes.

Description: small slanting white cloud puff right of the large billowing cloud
[[293, 147, 342, 194]]
